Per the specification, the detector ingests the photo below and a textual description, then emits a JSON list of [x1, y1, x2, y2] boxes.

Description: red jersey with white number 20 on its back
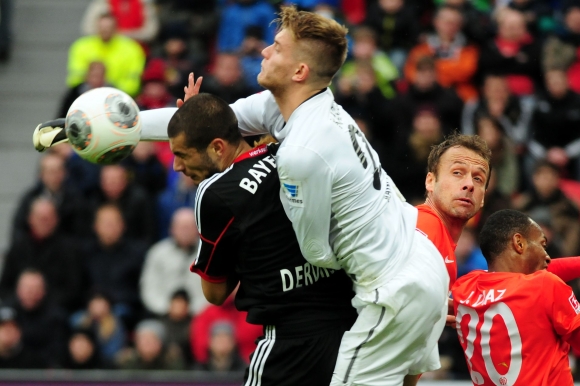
[[452, 270, 580, 386]]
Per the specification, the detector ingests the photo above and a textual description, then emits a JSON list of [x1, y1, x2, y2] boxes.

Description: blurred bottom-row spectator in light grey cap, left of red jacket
[[117, 319, 185, 370]]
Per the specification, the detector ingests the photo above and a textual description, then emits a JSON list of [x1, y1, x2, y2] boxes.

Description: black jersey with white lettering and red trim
[[191, 145, 356, 329]]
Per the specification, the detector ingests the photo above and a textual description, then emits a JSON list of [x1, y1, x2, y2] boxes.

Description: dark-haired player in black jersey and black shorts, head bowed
[[168, 94, 356, 386]]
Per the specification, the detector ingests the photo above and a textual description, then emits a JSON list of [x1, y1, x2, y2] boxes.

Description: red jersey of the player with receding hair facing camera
[[416, 204, 457, 289]]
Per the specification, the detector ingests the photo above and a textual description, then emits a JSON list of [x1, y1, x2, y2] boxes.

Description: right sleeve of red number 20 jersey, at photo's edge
[[544, 274, 580, 349]]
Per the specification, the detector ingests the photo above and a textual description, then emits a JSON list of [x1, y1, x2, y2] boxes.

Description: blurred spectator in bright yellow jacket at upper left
[[67, 14, 145, 96]]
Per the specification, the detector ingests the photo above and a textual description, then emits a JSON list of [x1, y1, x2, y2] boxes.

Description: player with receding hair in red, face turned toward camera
[[417, 134, 580, 288]]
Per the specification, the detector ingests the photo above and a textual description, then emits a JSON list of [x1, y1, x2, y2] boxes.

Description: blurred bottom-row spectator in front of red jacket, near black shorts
[[195, 320, 246, 373]]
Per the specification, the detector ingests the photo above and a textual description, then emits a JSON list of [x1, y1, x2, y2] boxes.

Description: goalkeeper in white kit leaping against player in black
[[32, 7, 449, 386]]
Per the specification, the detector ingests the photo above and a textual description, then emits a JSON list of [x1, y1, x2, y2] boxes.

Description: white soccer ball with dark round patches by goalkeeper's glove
[[65, 87, 141, 164]]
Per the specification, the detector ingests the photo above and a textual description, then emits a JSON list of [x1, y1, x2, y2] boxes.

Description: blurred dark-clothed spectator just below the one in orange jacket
[[390, 56, 463, 141]]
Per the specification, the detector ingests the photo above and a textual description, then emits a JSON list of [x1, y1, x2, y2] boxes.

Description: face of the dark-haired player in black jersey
[[169, 134, 221, 185]]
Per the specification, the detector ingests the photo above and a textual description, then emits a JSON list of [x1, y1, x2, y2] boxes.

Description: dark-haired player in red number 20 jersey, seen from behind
[[452, 210, 580, 386]]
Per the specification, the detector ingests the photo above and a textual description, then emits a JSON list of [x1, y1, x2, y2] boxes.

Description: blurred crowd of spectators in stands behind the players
[[0, 0, 580, 386]]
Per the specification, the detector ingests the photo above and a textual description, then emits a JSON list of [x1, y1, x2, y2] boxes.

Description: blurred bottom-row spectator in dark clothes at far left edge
[[0, 307, 44, 369]]
